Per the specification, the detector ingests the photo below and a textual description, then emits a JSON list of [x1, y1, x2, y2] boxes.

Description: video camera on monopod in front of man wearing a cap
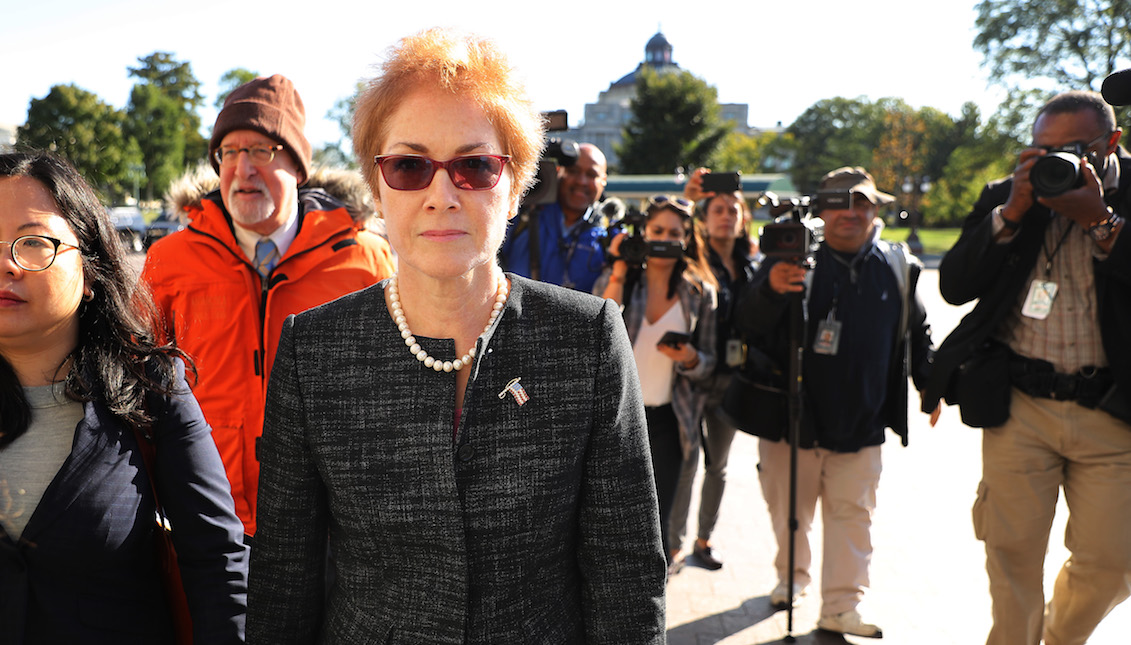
[[758, 191, 827, 267]]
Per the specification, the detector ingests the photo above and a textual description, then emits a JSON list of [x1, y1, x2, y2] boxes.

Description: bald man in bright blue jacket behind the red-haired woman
[[499, 144, 608, 292]]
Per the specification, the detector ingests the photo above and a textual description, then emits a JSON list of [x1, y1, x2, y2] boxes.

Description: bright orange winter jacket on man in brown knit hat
[[143, 189, 394, 535]]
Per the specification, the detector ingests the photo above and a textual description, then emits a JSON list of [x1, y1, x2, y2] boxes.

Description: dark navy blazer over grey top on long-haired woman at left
[[0, 362, 248, 645]]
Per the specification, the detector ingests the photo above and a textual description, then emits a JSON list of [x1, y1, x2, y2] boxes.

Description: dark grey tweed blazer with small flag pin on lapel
[[248, 274, 665, 645]]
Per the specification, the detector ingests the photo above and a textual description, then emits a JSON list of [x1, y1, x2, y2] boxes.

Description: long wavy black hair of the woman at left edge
[[0, 152, 185, 449]]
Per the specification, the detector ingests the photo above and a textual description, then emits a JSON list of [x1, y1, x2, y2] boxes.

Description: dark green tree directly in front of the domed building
[[616, 67, 731, 174]]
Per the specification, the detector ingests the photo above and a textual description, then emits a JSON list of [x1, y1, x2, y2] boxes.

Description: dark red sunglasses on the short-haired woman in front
[[373, 155, 510, 190]]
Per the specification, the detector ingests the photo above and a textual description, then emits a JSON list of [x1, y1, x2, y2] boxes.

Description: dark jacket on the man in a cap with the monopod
[[724, 234, 933, 453]]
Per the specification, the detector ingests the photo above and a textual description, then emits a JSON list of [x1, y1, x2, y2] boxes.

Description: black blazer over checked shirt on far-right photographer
[[924, 147, 1131, 409]]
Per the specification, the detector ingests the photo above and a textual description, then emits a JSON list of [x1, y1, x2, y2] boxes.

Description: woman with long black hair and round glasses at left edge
[[0, 153, 248, 645]]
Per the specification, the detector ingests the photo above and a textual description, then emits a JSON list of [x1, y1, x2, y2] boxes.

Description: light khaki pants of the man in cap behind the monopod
[[758, 439, 882, 616]]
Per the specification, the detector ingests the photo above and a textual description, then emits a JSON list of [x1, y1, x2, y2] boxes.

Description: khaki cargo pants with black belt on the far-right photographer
[[974, 389, 1131, 645]]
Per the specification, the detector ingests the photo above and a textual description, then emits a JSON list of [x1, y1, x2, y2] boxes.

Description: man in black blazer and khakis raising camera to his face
[[924, 86, 1131, 645]]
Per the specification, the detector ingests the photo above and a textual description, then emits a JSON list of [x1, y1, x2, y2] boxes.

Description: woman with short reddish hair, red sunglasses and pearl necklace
[[248, 29, 665, 645]]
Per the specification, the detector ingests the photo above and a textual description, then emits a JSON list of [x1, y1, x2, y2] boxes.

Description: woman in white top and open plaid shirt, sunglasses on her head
[[594, 195, 718, 574]]
